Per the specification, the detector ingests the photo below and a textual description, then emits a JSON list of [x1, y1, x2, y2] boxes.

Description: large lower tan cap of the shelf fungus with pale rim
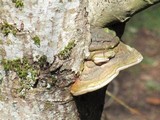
[[71, 42, 143, 96]]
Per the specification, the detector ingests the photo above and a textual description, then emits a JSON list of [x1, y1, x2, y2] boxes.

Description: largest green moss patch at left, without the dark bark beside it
[[1, 57, 40, 97]]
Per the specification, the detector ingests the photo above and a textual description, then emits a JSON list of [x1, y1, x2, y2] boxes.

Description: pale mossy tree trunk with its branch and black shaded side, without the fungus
[[0, 0, 159, 120]]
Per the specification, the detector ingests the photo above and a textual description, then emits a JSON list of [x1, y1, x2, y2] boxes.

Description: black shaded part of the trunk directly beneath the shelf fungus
[[74, 87, 107, 120]]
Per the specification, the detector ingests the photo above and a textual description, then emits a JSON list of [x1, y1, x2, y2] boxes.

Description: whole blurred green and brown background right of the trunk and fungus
[[103, 4, 160, 120]]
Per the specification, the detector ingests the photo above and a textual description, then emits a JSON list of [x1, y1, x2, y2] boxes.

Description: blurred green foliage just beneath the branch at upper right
[[123, 4, 160, 39]]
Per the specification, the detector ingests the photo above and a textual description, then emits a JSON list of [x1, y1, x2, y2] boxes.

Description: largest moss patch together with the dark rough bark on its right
[[0, 55, 56, 98]]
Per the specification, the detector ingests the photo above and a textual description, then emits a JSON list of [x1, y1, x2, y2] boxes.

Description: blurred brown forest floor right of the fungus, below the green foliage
[[103, 29, 160, 120]]
